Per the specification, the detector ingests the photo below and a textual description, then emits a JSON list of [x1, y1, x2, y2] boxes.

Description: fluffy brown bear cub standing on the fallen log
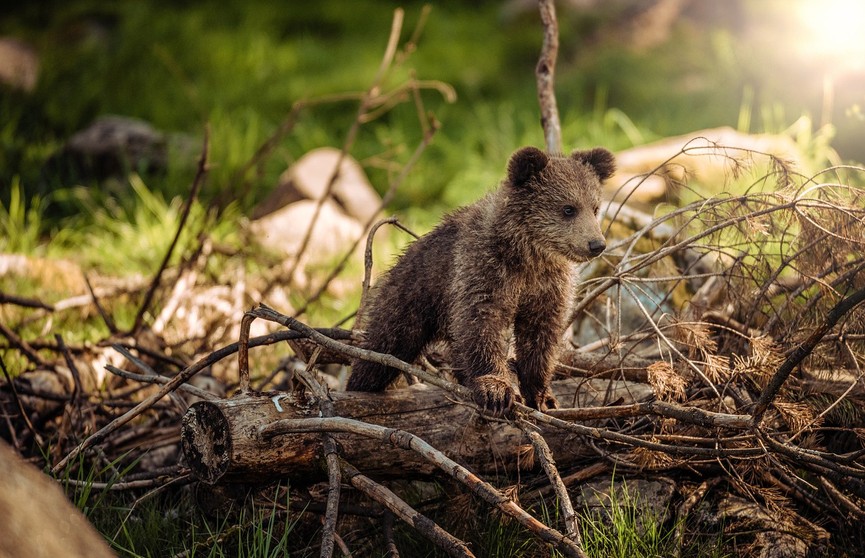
[[348, 147, 615, 414]]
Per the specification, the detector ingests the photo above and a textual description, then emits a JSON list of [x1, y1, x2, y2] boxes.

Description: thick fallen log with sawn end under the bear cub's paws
[[181, 378, 652, 484]]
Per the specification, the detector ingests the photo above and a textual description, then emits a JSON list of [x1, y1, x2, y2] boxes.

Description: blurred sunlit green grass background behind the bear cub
[[0, 0, 865, 238]]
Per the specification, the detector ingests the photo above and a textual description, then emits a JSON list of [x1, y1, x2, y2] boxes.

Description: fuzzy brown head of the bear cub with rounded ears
[[505, 147, 616, 261]]
